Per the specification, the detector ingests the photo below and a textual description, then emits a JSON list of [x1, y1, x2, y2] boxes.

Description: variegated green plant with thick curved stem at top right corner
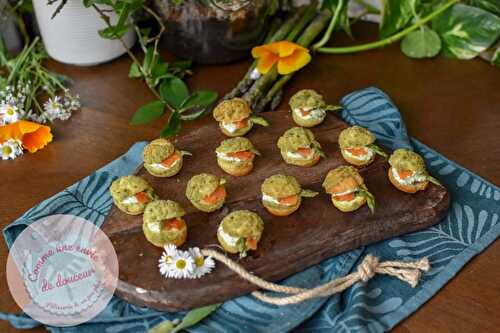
[[315, 0, 500, 64]]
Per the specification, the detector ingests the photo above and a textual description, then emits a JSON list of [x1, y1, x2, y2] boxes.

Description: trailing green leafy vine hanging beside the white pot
[[49, 0, 217, 137]]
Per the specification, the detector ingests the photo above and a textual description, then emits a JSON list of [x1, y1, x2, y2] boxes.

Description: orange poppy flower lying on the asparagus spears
[[252, 40, 311, 75]]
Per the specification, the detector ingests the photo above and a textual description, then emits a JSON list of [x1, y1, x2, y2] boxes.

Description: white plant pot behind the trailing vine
[[33, 0, 136, 66]]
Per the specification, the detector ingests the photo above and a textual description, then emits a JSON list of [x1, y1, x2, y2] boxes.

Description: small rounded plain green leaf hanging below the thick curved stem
[[401, 26, 441, 59]]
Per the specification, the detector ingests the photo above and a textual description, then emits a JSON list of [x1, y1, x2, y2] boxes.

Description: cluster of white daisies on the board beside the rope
[[158, 244, 215, 279]]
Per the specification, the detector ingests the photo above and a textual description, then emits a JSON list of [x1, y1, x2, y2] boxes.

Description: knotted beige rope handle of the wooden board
[[201, 249, 430, 305]]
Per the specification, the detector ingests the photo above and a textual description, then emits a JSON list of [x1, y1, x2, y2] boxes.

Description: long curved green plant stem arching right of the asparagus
[[316, 0, 459, 54]]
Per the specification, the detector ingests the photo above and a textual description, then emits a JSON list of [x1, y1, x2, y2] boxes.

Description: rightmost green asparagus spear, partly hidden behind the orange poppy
[[255, 10, 331, 112]]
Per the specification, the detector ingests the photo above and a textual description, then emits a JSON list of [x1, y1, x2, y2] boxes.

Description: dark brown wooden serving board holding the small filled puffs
[[103, 110, 450, 311]]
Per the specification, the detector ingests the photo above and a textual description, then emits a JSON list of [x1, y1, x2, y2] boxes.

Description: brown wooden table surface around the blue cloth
[[0, 23, 500, 333]]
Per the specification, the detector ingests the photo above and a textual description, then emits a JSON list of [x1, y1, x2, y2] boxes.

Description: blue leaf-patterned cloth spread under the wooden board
[[0, 88, 500, 333]]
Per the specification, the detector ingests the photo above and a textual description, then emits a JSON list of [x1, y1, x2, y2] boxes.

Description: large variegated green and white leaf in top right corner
[[432, 4, 500, 59]]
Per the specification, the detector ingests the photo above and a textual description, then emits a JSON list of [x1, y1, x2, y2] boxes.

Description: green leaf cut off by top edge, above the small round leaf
[[379, 0, 420, 39]]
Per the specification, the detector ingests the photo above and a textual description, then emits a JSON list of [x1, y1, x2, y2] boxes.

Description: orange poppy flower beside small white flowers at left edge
[[0, 120, 52, 153]]
